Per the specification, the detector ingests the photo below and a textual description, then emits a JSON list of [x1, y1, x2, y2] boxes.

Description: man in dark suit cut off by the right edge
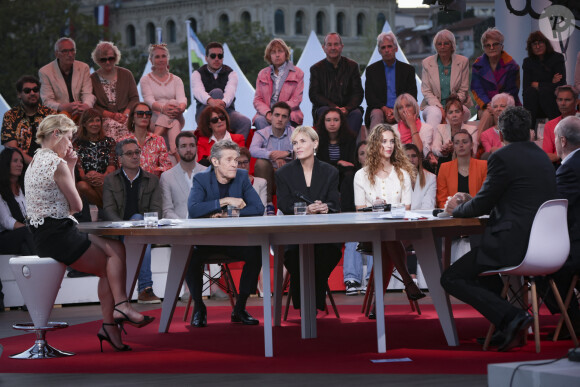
[[536, 116, 580, 339]]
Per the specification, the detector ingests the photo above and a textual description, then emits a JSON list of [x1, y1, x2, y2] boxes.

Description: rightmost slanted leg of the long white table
[[413, 230, 459, 346]]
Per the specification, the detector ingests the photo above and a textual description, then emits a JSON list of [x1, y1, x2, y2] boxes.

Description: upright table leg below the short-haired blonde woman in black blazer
[[302, 244, 316, 339]]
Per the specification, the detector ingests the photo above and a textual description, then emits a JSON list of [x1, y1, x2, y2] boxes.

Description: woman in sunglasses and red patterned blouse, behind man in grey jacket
[[119, 102, 171, 177]]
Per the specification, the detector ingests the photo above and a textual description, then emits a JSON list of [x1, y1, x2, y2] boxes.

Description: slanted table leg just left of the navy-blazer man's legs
[[159, 245, 193, 333]]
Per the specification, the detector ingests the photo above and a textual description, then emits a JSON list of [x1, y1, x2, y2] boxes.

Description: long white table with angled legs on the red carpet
[[79, 213, 482, 357]]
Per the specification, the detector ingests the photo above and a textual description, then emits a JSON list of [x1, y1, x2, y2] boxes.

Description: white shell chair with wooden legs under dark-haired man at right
[[480, 199, 578, 352]]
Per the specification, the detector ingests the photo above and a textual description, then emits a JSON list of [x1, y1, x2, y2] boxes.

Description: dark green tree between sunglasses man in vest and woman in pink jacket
[[198, 22, 272, 84]]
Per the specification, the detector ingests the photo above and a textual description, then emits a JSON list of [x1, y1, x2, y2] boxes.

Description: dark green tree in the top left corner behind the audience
[[0, 0, 105, 105]]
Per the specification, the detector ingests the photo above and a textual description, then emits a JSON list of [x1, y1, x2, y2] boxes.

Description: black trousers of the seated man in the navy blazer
[[185, 246, 262, 303]]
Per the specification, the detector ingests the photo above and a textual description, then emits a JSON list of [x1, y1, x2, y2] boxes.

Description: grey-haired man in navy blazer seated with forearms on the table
[[186, 140, 264, 328]]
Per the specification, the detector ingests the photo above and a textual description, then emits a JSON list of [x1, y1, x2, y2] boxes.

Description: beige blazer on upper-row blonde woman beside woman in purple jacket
[[421, 54, 473, 110]]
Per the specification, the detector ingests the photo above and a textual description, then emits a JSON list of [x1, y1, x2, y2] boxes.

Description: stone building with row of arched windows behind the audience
[[81, 0, 397, 62]]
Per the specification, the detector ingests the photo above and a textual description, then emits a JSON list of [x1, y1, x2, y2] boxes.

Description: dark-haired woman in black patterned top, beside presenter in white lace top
[[73, 108, 117, 208]]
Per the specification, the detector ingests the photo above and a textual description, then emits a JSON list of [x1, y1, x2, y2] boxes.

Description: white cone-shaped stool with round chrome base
[[9, 256, 74, 359]]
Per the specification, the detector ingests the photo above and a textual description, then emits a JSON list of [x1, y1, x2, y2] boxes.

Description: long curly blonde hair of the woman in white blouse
[[365, 124, 416, 186]]
